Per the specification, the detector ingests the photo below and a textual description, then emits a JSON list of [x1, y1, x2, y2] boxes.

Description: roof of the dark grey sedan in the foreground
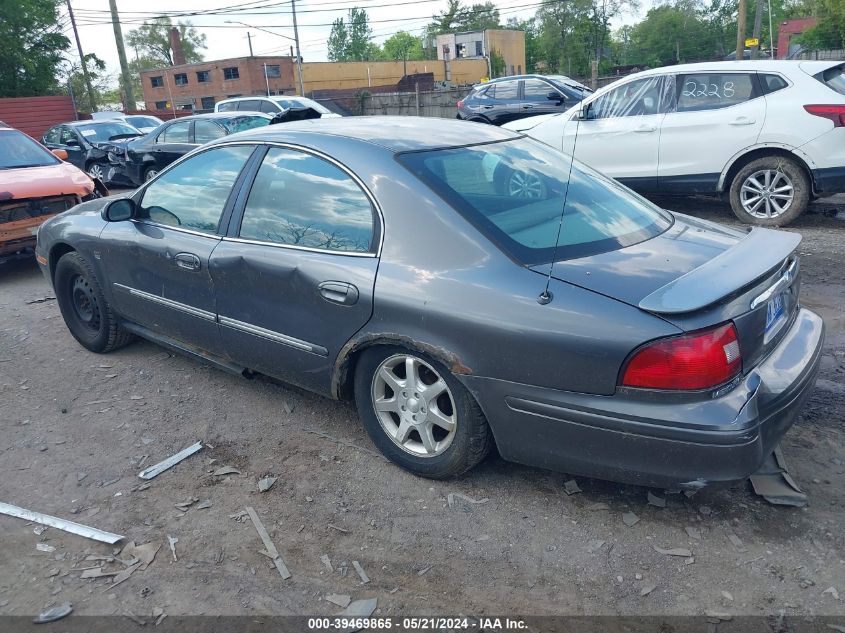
[[229, 116, 522, 152]]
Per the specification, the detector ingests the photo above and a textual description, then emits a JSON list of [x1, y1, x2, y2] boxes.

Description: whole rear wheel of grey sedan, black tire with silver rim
[[355, 346, 493, 479]]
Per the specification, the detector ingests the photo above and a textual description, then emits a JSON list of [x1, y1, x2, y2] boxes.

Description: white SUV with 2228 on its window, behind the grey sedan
[[503, 60, 845, 226]]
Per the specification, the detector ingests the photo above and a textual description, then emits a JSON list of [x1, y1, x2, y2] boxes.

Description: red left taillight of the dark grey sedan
[[622, 323, 742, 390]]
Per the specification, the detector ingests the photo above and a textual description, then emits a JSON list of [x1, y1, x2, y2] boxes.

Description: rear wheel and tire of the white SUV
[[730, 154, 812, 226]]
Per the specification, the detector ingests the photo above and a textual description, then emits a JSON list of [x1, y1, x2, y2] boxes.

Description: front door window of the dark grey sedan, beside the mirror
[[138, 145, 252, 233]]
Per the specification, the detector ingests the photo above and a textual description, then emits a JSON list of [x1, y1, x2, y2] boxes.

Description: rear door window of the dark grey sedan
[[240, 147, 374, 253]]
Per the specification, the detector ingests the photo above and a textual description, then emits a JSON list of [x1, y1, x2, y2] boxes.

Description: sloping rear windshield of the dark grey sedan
[[399, 138, 672, 265]]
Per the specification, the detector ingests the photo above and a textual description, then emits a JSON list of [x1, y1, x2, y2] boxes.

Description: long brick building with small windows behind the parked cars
[[141, 56, 297, 110]]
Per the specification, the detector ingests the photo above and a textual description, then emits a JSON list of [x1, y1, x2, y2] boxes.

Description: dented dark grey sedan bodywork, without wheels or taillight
[[38, 117, 823, 488]]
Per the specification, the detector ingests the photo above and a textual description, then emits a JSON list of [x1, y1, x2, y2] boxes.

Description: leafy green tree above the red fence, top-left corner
[[0, 0, 70, 97]]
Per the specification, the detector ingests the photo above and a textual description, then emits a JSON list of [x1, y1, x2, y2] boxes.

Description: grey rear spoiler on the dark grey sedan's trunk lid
[[639, 228, 801, 314]]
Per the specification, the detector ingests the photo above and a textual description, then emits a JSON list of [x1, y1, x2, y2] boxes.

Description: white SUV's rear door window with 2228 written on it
[[676, 73, 758, 112]]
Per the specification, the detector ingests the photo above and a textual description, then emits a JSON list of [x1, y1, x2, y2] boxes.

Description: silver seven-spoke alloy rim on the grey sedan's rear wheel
[[372, 354, 458, 457]]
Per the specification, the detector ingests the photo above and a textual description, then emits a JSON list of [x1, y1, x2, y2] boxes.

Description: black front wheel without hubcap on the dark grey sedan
[[53, 251, 133, 353]]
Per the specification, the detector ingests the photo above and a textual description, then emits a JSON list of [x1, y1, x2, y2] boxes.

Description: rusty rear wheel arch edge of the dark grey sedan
[[331, 332, 473, 400]]
